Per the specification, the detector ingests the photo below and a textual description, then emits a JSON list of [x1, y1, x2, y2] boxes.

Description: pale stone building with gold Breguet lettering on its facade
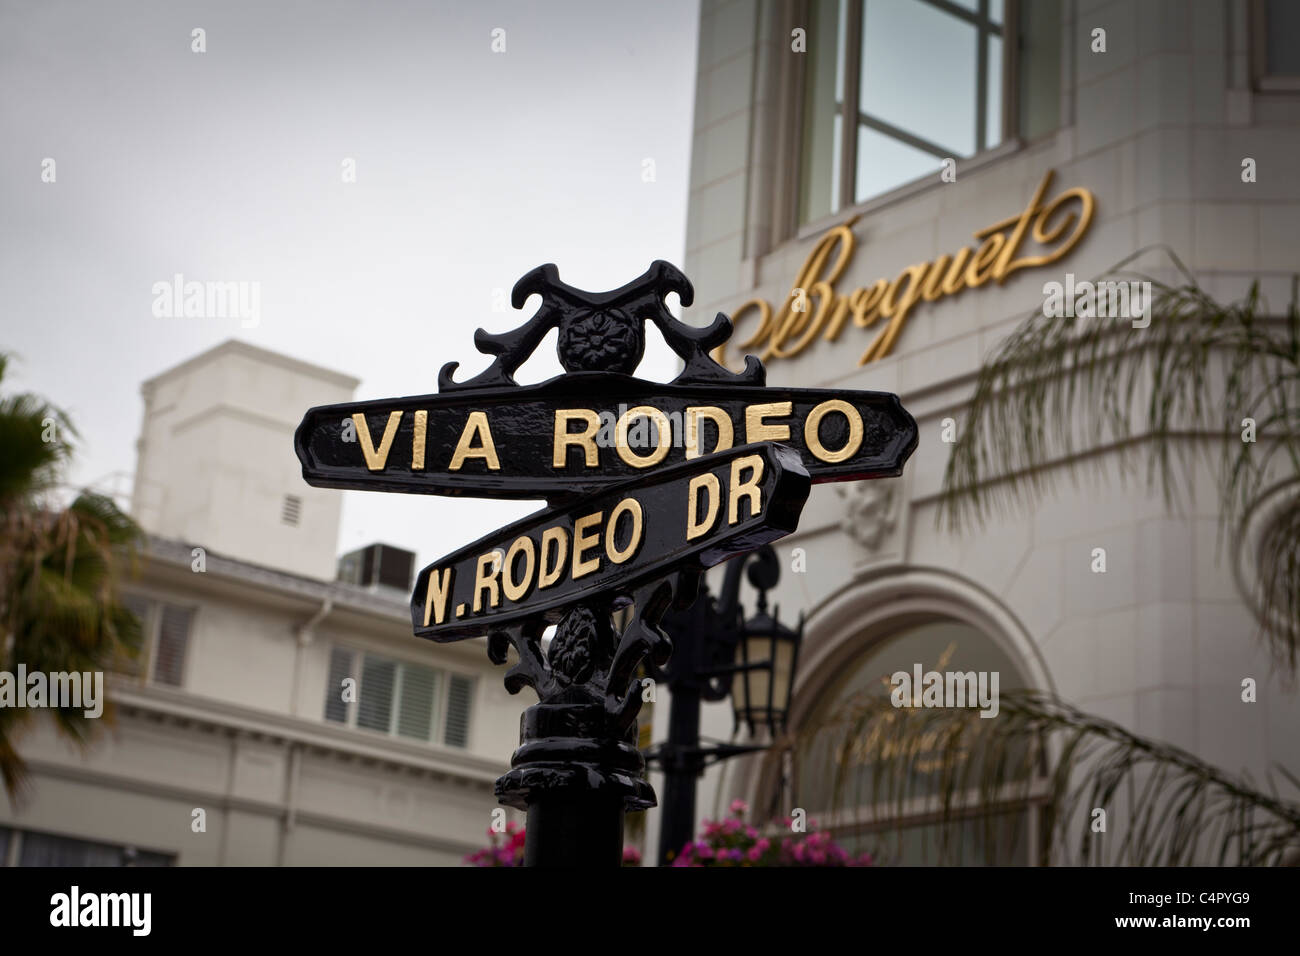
[[651, 0, 1300, 858]]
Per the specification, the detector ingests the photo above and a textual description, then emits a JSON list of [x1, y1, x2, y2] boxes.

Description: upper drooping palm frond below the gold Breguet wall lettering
[[937, 250, 1300, 672]]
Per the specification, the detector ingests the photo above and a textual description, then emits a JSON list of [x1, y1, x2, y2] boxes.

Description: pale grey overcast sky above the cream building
[[0, 0, 698, 574]]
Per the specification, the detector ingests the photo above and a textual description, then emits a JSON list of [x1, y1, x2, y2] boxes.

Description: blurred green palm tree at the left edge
[[0, 354, 140, 797]]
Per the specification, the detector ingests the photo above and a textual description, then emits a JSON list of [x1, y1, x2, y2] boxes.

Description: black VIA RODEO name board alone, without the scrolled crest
[[295, 372, 917, 498]]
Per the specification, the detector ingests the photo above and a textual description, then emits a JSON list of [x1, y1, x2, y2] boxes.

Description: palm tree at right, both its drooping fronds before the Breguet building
[[792, 250, 1300, 865]]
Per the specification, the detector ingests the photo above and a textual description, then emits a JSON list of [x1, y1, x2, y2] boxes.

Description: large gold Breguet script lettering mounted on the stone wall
[[714, 170, 1096, 365]]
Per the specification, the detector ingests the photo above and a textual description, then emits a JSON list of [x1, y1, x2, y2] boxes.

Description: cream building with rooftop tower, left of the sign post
[[0, 341, 523, 865]]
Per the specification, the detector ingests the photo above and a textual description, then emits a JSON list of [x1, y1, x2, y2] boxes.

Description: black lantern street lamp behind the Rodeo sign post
[[646, 545, 803, 865]]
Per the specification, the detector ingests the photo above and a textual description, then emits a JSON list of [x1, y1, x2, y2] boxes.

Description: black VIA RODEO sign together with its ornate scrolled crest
[[294, 261, 917, 499]]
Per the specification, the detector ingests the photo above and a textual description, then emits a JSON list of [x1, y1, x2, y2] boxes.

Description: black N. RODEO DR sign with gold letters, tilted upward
[[411, 444, 810, 641]]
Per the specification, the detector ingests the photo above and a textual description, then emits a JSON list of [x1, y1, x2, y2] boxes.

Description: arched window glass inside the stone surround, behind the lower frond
[[768, 620, 1045, 865]]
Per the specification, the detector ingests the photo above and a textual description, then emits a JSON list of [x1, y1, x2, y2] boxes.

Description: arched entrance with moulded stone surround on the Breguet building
[[745, 568, 1052, 864]]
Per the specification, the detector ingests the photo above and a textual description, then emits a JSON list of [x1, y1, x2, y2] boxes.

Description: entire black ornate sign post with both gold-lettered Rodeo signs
[[294, 261, 917, 866]]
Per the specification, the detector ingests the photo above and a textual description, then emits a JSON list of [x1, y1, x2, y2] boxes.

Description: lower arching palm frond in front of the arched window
[[800, 691, 1300, 866]]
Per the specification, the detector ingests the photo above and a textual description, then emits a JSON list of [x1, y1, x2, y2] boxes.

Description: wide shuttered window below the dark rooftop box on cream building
[[325, 648, 475, 748]]
